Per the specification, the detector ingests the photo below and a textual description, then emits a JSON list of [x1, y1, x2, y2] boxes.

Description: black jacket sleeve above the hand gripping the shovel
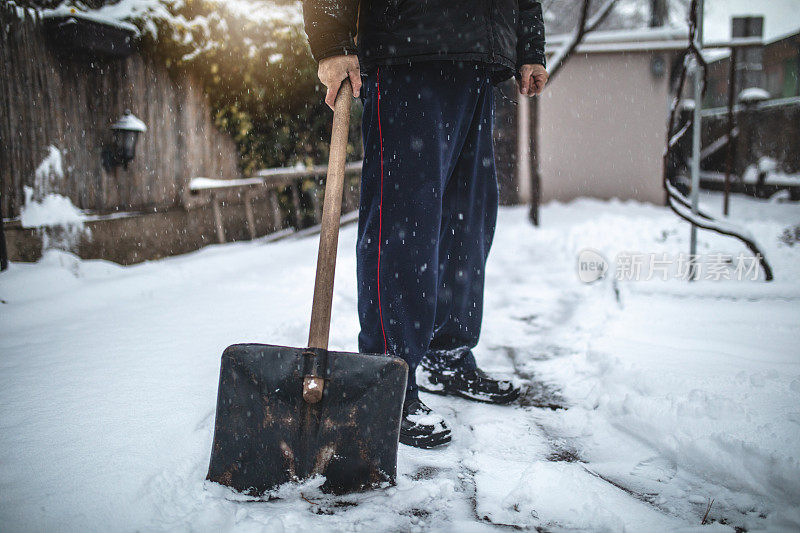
[[303, 0, 358, 61]]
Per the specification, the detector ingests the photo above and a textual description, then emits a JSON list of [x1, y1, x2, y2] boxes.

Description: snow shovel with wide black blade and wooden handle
[[207, 80, 408, 496]]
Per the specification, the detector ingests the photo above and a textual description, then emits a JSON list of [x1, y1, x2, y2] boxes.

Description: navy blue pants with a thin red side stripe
[[356, 61, 498, 397]]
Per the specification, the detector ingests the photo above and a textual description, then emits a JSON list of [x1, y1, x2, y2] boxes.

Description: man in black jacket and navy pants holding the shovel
[[303, 0, 547, 448]]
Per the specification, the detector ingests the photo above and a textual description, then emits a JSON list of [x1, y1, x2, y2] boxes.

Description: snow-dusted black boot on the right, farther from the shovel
[[418, 365, 519, 404]]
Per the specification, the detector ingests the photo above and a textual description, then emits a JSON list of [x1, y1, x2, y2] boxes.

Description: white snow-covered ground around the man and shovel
[[0, 195, 800, 531]]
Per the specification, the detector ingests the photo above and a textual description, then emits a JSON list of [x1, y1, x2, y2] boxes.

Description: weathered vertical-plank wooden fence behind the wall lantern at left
[[0, 3, 239, 218]]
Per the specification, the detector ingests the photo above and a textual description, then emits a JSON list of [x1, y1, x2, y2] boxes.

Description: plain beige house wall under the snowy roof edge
[[539, 52, 674, 204]]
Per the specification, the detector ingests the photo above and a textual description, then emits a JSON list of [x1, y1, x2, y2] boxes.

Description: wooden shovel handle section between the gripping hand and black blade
[[308, 79, 353, 350]]
